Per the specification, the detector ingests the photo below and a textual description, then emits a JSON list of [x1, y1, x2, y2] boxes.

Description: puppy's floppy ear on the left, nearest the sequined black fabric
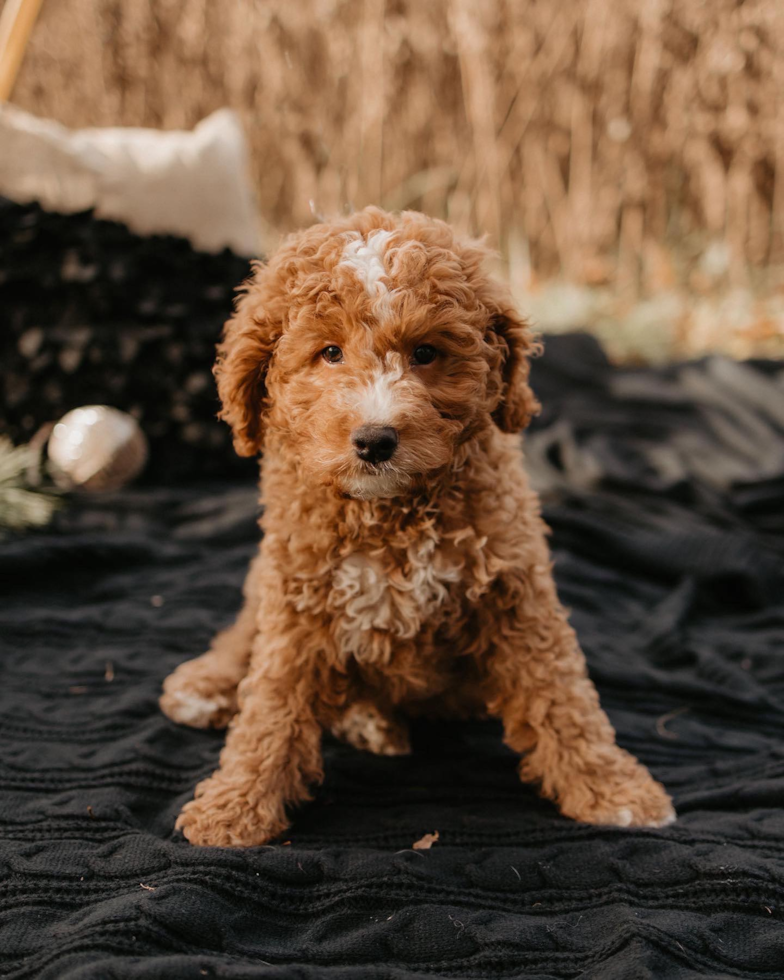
[[213, 265, 283, 456]]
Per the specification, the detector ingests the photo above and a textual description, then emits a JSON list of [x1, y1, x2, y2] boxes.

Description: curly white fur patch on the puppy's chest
[[330, 541, 461, 662]]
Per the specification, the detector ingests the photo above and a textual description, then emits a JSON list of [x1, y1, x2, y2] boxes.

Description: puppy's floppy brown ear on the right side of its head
[[485, 287, 542, 432]]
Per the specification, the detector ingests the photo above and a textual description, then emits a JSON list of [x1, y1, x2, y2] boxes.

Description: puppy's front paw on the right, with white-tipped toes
[[558, 749, 677, 827]]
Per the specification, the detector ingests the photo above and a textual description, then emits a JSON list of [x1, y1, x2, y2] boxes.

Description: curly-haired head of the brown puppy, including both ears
[[215, 208, 537, 498]]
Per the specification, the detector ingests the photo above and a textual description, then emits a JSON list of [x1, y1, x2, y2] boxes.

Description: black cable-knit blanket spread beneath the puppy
[[0, 336, 784, 980]]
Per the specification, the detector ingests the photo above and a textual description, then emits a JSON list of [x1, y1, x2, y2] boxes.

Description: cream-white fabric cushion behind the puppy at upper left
[[0, 104, 262, 256]]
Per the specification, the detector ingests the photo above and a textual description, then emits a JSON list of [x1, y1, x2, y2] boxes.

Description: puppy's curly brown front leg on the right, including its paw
[[489, 564, 675, 827]]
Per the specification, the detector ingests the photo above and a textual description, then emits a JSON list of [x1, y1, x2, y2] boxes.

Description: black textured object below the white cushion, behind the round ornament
[[0, 198, 255, 481]]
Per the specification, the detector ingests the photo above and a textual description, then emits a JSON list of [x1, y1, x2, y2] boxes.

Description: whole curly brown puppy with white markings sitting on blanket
[[161, 208, 675, 846]]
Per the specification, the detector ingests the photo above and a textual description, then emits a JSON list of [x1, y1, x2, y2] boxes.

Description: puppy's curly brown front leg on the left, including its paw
[[177, 645, 322, 847]]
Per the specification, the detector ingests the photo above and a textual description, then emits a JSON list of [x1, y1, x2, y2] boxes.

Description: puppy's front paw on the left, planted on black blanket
[[175, 774, 288, 847]]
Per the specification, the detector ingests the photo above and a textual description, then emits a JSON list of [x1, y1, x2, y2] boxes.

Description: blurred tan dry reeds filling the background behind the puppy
[[6, 0, 784, 360]]
